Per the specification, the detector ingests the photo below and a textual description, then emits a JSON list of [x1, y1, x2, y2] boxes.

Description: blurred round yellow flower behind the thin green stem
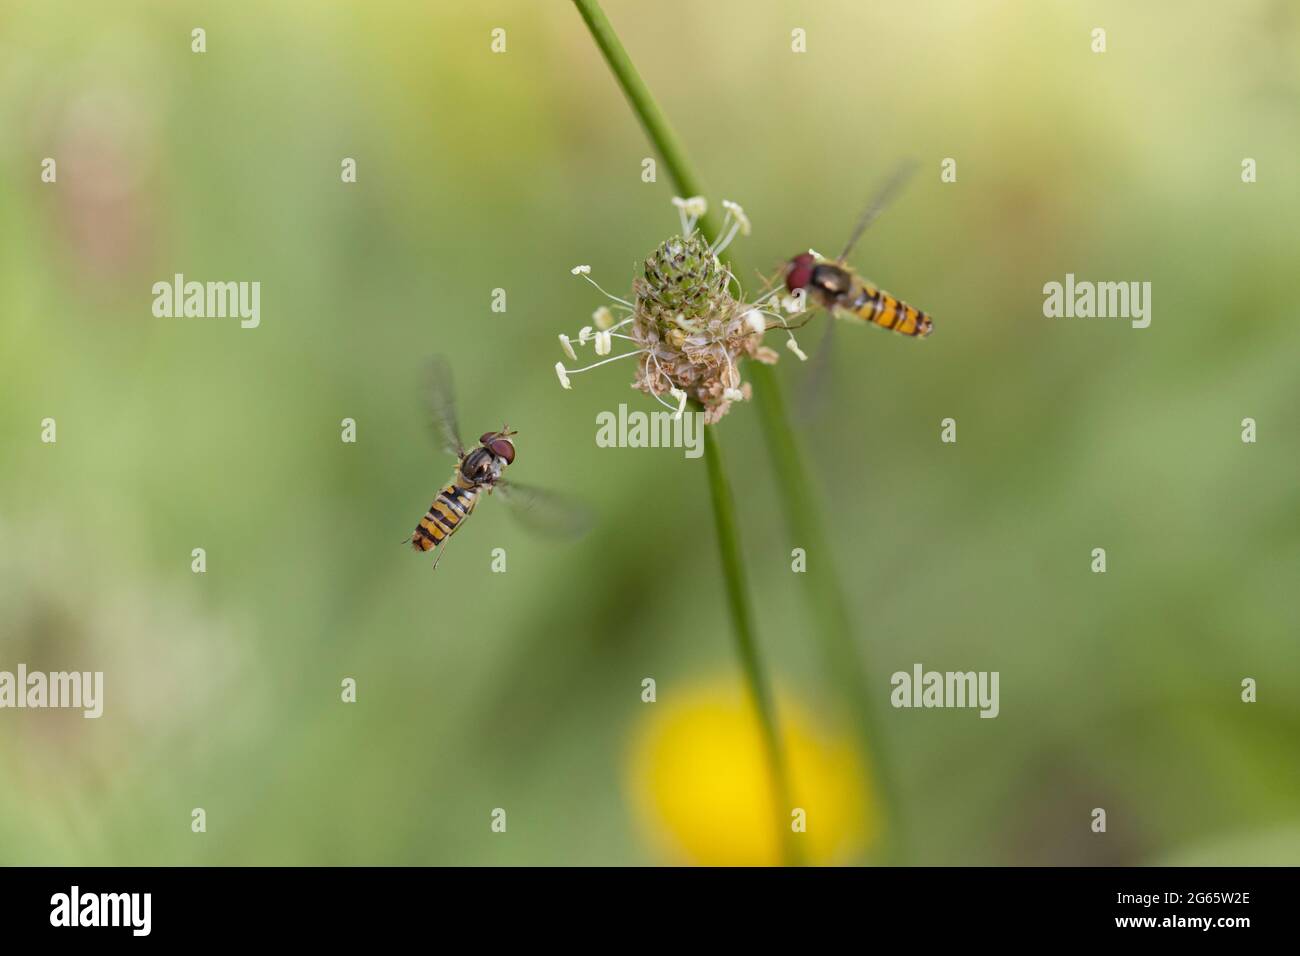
[[629, 682, 879, 866]]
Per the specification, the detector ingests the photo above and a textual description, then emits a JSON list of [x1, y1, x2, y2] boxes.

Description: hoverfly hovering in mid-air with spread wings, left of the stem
[[410, 358, 589, 568]]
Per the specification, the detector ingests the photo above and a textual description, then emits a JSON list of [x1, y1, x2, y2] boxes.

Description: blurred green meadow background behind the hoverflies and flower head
[[0, 0, 1300, 864]]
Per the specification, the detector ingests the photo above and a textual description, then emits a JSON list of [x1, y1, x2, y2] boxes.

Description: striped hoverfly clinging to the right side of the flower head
[[785, 164, 933, 337]]
